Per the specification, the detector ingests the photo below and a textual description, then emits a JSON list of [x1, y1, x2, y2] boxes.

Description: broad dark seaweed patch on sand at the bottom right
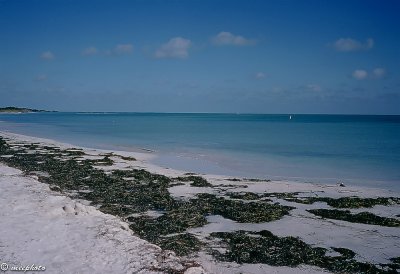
[[210, 230, 396, 273]]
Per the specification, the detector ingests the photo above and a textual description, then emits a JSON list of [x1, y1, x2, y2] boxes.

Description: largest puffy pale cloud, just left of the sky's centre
[[155, 37, 192, 58]]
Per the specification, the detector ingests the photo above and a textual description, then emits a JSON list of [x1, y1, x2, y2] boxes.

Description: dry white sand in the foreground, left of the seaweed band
[[0, 163, 202, 273]]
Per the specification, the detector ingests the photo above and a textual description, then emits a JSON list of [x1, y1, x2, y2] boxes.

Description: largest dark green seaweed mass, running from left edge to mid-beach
[[0, 138, 292, 253]]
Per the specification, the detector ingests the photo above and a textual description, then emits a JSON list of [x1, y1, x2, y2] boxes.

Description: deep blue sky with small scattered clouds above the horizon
[[0, 0, 400, 114]]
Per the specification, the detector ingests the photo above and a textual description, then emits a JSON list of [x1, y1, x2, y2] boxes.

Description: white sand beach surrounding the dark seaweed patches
[[0, 132, 400, 273]]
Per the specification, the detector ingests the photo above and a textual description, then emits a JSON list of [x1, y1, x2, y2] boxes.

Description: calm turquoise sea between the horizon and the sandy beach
[[0, 113, 400, 190]]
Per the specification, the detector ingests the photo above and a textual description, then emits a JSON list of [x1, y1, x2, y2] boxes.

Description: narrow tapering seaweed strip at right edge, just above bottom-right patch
[[307, 209, 400, 227]]
